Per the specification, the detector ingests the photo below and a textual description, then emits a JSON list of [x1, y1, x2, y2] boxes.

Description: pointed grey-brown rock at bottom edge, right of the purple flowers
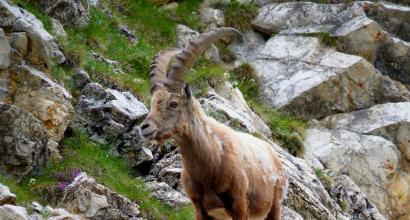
[[59, 173, 140, 220]]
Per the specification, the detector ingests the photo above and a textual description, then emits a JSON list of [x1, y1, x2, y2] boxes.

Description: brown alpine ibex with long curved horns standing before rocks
[[141, 28, 287, 220]]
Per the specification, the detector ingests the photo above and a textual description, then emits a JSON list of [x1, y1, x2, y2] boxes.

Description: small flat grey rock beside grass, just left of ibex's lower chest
[[146, 182, 190, 207]]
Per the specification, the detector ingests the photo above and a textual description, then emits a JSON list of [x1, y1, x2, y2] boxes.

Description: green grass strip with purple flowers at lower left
[[0, 132, 194, 220]]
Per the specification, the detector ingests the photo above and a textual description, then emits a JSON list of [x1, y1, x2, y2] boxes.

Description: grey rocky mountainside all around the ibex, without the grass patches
[[0, 0, 410, 220]]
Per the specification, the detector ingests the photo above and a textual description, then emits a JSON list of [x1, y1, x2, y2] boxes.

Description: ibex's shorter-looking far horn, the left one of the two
[[149, 48, 181, 94]]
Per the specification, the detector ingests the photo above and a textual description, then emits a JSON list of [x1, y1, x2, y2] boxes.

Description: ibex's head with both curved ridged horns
[[141, 27, 241, 142]]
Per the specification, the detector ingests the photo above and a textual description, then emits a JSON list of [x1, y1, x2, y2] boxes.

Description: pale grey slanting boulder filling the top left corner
[[0, 0, 65, 65]]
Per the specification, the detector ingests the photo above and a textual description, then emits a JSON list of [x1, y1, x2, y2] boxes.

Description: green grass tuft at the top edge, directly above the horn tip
[[214, 0, 258, 31]]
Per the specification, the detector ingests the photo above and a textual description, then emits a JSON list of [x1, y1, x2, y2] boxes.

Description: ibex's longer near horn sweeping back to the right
[[165, 27, 242, 93]]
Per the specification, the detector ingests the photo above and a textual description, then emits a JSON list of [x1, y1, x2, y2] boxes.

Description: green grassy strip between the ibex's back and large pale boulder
[[230, 63, 307, 156]]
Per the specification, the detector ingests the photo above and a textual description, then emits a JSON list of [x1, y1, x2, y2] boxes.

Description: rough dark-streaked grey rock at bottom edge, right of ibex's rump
[[331, 175, 386, 220]]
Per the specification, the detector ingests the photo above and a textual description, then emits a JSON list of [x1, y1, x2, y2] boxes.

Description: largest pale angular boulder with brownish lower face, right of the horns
[[251, 35, 410, 118]]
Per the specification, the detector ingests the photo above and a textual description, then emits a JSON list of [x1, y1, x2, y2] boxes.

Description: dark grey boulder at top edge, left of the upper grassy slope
[[37, 0, 90, 26]]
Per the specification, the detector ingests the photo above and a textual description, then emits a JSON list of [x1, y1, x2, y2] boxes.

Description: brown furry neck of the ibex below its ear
[[175, 101, 222, 176]]
